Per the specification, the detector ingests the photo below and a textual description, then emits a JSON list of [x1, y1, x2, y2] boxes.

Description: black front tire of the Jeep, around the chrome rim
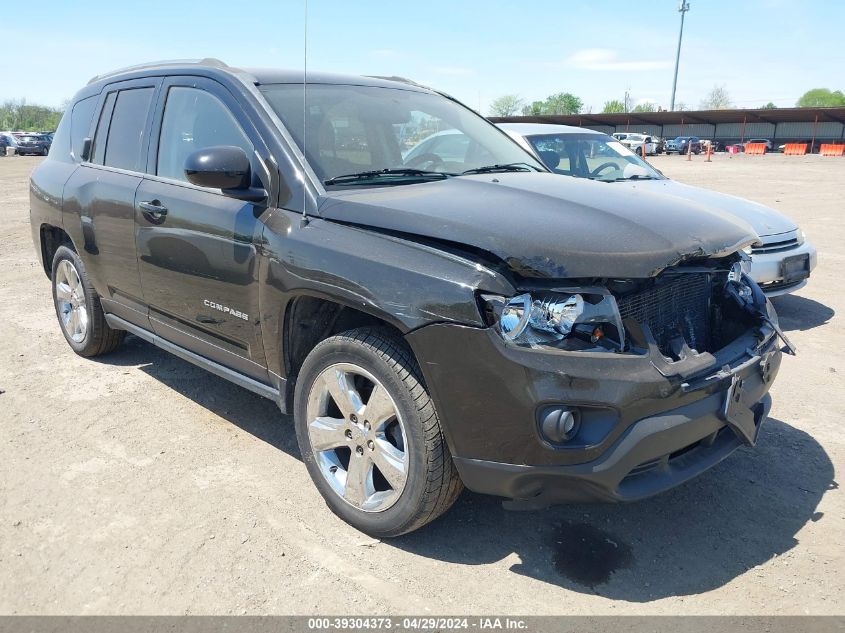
[[294, 328, 463, 538]]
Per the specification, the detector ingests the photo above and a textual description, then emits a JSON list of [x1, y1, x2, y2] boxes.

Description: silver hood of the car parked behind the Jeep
[[614, 180, 798, 237]]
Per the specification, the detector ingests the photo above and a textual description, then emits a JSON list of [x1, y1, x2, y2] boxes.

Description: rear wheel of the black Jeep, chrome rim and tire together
[[52, 246, 126, 356]]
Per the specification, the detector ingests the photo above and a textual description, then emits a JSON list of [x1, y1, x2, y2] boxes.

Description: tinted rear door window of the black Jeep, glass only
[[103, 88, 154, 171]]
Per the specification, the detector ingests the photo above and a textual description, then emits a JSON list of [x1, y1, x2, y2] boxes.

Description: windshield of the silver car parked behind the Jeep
[[527, 134, 663, 182]]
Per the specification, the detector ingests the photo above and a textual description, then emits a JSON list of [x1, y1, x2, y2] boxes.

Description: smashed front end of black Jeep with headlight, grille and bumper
[[409, 254, 794, 507]]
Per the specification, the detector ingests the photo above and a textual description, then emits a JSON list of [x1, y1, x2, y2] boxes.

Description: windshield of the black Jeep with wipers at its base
[[260, 84, 545, 186]]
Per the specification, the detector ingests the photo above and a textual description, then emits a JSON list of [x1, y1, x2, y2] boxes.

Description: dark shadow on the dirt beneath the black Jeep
[[101, 337, 838, 602]]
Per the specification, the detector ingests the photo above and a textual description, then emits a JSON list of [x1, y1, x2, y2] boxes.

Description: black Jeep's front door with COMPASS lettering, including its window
[[135, 77, 270, 381]]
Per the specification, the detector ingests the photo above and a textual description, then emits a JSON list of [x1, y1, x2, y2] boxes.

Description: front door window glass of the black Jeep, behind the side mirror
[[156, 87, 253, 180]]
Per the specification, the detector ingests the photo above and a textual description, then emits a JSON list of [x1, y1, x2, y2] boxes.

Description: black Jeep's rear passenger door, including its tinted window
[[63, 77, 161, 328]]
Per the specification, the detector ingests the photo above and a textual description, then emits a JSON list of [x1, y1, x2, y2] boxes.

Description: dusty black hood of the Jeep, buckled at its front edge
[[318, 172, 756, 279]]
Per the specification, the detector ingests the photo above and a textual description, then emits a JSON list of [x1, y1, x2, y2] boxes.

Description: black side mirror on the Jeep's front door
[[185, 145, 267, 202]]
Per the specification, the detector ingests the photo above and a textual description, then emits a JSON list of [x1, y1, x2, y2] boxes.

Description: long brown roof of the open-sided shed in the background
[[490, 107, 845, 126]]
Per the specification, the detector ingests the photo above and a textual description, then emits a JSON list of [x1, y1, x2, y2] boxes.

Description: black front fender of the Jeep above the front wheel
[[254, 209, 515, 375]]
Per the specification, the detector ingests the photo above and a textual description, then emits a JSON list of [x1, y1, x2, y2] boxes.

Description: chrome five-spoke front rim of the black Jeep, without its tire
[[306, 363, 409, 512]]
